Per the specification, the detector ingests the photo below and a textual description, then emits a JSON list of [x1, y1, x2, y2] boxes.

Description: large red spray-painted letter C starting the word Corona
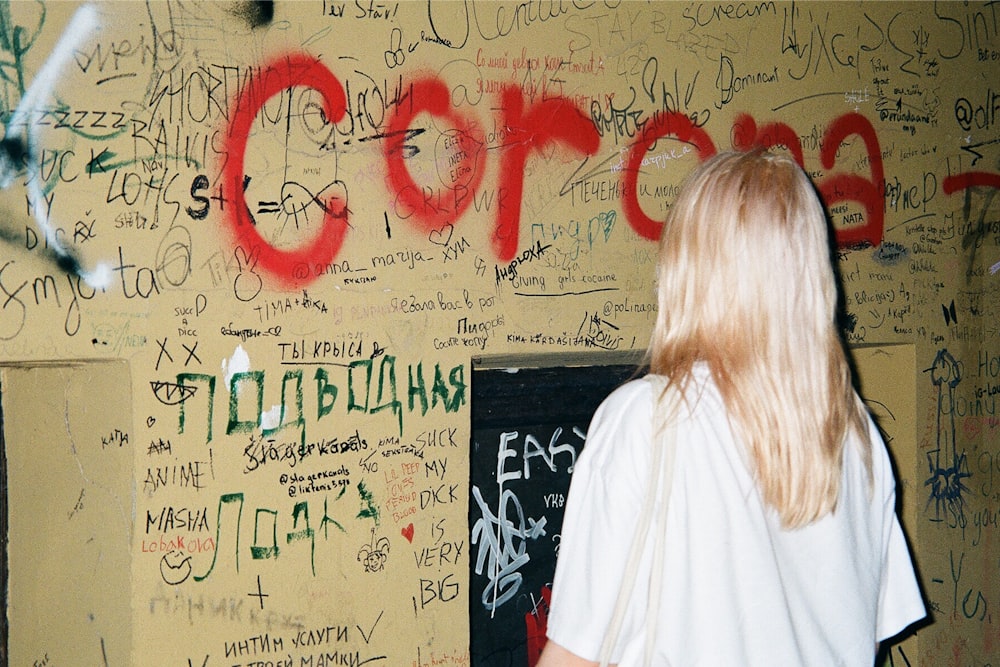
[[222, 55, 347, 286]]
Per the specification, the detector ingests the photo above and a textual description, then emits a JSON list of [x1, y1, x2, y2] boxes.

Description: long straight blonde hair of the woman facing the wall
[[649, 150, 871, 528]]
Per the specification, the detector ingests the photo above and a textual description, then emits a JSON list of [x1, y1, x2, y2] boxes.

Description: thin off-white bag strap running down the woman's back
[[600, 374, 680, 667]]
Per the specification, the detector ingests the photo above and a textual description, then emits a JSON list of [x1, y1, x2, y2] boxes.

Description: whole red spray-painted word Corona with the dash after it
[[223, 55, 1000, 285]]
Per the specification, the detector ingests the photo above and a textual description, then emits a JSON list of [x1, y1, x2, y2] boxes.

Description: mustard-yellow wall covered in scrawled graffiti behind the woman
[[0, 0, 1000, 665]]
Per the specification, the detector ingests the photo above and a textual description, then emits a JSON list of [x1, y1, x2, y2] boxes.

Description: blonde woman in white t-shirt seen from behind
[[539, 151, 925, 667]]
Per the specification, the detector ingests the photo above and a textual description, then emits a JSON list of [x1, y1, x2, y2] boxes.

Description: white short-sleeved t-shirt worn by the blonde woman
[[547, 366, 925, 667]]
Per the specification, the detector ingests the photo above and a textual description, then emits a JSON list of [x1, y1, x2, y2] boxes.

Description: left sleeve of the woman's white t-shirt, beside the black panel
[[547, 381, 652, 660]]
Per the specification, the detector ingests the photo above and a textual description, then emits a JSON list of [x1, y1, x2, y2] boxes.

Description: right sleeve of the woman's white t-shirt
[[872, 426, 927, 641]]
